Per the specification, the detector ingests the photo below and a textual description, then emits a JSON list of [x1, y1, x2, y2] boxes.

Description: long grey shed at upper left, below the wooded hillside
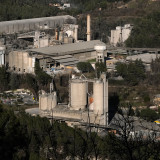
[[0, 15, 76, 34]]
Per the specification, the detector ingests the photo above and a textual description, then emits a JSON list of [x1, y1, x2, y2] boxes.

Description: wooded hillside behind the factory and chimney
[[0, 0, 160, 47]]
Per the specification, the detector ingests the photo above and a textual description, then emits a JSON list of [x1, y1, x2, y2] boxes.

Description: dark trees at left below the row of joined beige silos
[[0, 63, 52, 97]]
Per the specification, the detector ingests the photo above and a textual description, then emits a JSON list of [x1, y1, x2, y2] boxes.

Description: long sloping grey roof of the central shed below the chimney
[[28, 40, 104, 56]]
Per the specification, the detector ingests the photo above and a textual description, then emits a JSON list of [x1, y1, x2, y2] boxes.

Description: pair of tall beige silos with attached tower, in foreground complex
[[70, 74, 108, 115]]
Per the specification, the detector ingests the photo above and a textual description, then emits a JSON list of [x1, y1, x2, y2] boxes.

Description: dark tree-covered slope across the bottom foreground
[[0, 105, 160, 160]]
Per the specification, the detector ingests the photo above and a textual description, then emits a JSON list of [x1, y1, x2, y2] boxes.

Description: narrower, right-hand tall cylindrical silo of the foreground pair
[[93, 80, 103, 114]]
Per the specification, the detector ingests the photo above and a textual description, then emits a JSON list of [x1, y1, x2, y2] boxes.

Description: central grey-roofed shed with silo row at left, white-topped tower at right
[[8, 40, 106, 73]]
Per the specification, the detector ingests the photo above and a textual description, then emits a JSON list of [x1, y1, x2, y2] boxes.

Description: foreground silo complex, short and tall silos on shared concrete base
[[38, 74, 108, 127]]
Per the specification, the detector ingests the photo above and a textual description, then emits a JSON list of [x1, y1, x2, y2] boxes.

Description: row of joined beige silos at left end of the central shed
[[8, 51, 35, 73]]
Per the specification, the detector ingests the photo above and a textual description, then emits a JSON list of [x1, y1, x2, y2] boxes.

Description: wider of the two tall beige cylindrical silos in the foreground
[[70, 79, 87, 110]]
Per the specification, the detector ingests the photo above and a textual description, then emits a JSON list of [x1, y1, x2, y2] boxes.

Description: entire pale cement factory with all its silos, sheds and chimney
[[0, 12, 159, 128]]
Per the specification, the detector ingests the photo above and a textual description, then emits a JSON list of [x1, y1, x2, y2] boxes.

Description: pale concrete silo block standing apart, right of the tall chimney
[[110, 24, 133, 46]]
